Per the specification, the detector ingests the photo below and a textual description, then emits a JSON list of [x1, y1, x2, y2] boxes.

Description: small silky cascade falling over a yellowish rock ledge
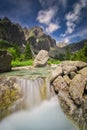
[[11, 78, 53, 112]]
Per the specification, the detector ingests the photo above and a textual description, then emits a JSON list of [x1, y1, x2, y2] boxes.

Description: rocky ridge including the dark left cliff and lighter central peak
[[0, 17, 56, 52]]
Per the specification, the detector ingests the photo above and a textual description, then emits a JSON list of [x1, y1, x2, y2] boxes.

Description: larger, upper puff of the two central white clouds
[[37, 8, 57, 25]]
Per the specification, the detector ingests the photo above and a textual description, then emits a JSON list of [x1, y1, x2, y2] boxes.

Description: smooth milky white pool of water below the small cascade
[[0, 96, 77, 130]]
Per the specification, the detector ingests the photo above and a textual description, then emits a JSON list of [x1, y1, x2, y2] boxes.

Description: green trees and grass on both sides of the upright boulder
[[0, 39, 87, 67]]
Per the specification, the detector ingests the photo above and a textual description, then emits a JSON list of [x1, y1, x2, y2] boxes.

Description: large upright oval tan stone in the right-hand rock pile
[[69, 74, 86, 105]]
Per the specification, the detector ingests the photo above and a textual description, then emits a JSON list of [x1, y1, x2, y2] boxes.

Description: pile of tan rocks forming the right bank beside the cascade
[[51, 61, 87, 130]]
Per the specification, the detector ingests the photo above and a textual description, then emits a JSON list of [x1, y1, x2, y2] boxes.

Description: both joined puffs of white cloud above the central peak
[[36, 7, 60, 33]]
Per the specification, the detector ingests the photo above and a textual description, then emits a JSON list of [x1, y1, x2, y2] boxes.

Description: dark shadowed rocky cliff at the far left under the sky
[[0, 17, 25, 45]]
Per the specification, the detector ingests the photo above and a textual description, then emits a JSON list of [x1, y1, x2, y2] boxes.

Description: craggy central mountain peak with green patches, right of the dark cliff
[[24, 27, 56, 53]]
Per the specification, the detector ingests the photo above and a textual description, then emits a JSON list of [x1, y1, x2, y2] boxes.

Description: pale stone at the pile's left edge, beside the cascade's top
[[50, 66, 62, 82]]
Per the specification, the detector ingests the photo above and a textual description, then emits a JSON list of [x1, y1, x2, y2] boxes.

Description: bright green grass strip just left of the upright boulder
[[11, 59, 33, 67]]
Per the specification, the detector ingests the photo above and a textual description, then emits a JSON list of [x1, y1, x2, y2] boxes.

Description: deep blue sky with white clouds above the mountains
[[0, 0, 87, 43]]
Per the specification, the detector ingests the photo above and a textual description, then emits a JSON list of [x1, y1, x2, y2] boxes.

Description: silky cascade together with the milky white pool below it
[[0, 68, 78, 130]]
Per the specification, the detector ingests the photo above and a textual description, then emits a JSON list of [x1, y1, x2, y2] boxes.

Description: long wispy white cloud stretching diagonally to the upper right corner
[[62, 0, 87, 37]]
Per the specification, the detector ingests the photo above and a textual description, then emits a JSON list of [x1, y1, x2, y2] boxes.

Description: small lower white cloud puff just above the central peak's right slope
[[46, 23, 60, 33]]
